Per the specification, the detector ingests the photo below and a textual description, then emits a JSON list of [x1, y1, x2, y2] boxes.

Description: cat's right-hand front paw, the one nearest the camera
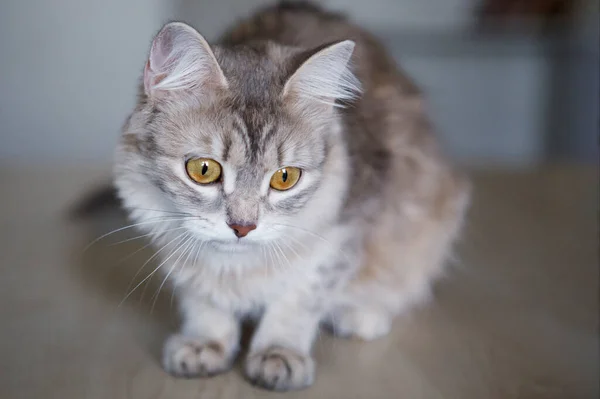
[[246, 346, 315, 391]]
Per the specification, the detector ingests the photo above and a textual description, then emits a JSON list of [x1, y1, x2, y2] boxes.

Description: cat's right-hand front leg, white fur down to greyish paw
[[245, 297, 322, 391]]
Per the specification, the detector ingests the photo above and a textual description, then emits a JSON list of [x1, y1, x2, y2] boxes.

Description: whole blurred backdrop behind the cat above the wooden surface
[[0, 0, 599, 167]]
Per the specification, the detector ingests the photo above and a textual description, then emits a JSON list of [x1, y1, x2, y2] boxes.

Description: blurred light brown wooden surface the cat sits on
[[0, 167, 599, 399]]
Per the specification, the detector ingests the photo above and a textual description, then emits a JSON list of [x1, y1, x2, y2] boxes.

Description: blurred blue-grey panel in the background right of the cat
[[384, 33, 550, 166]]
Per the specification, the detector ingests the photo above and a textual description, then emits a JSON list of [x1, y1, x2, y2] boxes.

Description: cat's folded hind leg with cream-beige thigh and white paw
[[324, 197, 460, 341]]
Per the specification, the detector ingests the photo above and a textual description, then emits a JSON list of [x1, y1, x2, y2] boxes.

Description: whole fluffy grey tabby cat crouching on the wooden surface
[[116, 1, 468, 390]]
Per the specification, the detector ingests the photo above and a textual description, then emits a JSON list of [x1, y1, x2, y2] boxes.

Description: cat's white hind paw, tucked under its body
[[329, 309, 392, 341]]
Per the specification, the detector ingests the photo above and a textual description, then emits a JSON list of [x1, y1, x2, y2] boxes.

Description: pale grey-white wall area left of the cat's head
[[0, 0, 169, 161]]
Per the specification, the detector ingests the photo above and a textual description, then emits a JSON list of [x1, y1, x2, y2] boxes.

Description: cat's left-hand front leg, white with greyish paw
[[163, 299, 240, 378]]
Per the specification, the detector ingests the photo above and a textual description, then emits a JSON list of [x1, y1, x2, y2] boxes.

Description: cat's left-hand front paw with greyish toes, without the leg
[[163, 334, 234, 378]]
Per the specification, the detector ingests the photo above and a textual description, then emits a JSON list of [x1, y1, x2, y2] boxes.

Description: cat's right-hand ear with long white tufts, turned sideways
[[283, 40, 360, 105]]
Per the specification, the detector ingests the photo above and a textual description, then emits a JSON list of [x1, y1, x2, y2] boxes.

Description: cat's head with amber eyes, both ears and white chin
[[116, 23, 359, 252]]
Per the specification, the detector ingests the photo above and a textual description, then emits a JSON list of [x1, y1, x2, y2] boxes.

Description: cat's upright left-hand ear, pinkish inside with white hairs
[[144, 22, 227, 96]]
